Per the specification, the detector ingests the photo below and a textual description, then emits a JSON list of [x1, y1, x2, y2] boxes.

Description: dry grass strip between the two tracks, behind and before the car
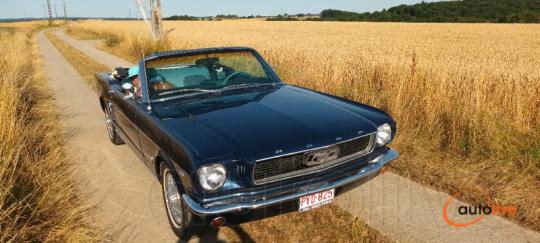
[[47, 27, 390, 242]]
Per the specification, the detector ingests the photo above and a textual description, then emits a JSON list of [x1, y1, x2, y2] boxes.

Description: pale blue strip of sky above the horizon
[[0, 0, 430, 19]]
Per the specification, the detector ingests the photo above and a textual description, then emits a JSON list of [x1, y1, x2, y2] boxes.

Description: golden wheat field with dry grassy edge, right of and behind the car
[[66, 21, 540, 229]]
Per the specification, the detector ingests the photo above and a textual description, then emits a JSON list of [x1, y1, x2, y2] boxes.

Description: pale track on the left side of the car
[[38, 32, 229, 242]]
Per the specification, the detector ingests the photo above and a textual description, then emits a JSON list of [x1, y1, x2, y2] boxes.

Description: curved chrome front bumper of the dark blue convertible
[[182, 149, 399, 215]]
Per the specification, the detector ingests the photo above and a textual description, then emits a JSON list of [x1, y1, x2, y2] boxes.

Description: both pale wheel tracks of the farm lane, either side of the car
[[39, 31, 540, 242]]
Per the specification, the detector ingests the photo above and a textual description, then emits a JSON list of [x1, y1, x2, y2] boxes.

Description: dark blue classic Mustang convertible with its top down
[[97, 47, 398, 238]]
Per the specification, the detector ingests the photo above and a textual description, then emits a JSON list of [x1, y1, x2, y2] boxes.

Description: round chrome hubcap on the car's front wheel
[[163, 170, 183, 227]]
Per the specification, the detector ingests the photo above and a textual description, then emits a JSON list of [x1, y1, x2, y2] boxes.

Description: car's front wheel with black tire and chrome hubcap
[[160, 163, 198, 240]]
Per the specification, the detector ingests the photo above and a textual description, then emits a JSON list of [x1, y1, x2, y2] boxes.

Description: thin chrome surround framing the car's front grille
[[251, 132, 376, 185]]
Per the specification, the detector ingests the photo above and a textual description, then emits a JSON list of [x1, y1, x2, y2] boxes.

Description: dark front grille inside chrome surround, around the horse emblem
[[253, 135, 373, 184]]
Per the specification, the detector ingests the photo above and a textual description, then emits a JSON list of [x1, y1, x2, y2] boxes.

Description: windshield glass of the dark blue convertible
[[146, 51, 278, 100]]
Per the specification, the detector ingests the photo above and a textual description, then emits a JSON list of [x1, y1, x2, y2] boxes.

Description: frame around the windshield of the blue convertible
[[139, 47, 283, 103]]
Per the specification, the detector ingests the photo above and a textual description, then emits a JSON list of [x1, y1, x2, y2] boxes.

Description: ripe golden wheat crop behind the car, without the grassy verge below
[[67, 21, 540, 153]]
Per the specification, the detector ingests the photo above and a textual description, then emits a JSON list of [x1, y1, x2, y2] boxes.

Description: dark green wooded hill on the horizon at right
[[320, 0, 540, 23]]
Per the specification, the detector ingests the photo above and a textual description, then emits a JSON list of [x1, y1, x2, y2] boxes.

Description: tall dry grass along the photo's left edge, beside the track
[[0, 25, 100, 242]]
